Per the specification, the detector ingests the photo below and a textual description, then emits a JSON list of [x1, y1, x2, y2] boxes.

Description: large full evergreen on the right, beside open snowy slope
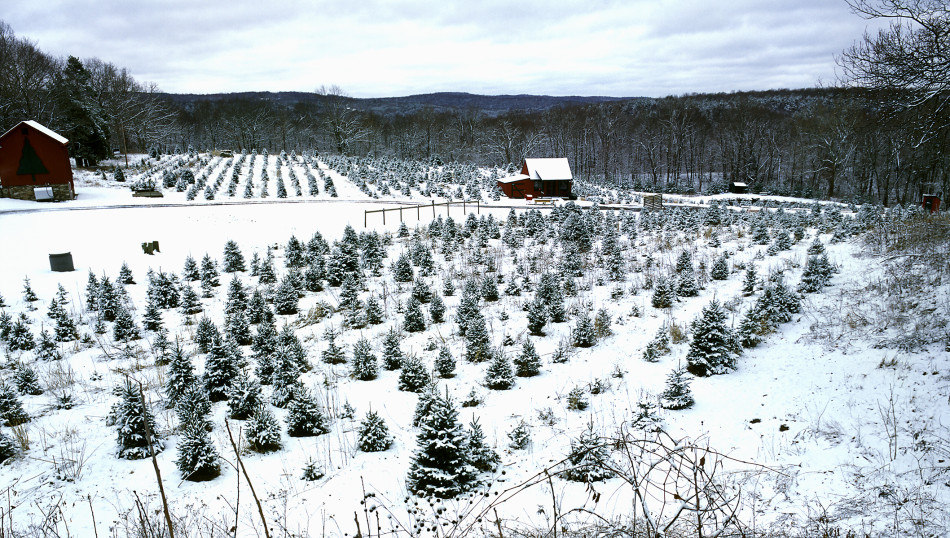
[[686, 299, 741, 377]]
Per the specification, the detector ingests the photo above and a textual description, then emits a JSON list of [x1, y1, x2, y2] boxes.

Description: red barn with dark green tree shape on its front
[[0, 120, 76, 200]]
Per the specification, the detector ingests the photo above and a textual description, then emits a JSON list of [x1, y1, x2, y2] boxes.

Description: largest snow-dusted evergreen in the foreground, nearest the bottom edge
[[406, 386, 476, 499]]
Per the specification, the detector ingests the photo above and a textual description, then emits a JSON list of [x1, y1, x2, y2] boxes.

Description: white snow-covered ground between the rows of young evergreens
[[0, 153, 950, 536]]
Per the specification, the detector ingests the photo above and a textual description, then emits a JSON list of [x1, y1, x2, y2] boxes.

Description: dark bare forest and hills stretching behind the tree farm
[[0, 17, 950, 205]]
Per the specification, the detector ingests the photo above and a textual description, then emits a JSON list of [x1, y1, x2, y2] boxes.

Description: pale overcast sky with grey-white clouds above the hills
[[0, 0, 888, 97]]
